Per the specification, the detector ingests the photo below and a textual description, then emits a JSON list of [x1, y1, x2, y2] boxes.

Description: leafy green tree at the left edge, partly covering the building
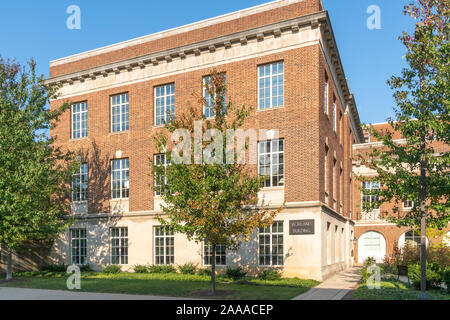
[[0, 57, 77, 280]]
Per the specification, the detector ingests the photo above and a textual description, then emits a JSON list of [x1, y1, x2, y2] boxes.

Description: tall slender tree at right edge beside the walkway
[[358, 0, 450, 298]]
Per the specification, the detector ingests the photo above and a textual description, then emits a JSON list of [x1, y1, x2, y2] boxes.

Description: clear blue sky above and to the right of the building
[[0, 0, 413, 123]]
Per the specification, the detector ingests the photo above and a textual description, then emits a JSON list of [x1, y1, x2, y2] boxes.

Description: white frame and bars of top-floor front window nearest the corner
[[258, 61, 286, 110]]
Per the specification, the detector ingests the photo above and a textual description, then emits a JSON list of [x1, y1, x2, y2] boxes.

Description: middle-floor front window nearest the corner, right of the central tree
[[258, 139, 284, 187]]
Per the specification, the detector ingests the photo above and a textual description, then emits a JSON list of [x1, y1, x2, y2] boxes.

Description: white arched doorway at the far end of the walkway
[[358, 231, 386, 263]]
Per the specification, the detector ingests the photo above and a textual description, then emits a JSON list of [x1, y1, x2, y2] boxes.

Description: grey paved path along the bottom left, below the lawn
[[0, 287, 197, 300]]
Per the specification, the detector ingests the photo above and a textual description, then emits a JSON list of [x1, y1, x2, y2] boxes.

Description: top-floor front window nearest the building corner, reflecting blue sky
[[258, 62, 284, 110]]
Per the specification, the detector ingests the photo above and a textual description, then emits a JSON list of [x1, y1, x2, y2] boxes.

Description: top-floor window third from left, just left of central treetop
[[155, 83, 175, 126]]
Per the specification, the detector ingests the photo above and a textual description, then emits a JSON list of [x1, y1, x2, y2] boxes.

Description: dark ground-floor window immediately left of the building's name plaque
[[259, 221, 283, 266]]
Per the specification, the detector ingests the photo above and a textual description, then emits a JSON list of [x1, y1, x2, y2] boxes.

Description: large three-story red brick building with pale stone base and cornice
[[47, 0, 364, 280]]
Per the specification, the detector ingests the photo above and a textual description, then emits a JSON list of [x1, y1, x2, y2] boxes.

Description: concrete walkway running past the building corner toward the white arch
[[292, 267, 361, 300]]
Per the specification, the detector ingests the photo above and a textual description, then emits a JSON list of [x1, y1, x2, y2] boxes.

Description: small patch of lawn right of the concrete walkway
[[351, 280, 450, 300]]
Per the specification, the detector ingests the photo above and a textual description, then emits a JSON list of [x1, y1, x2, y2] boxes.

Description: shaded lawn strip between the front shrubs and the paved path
[[0, 272, 319, 300]]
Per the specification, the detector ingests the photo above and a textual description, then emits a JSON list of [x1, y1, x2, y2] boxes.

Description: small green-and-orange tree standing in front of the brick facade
[[152, 70, 281, 295]]
